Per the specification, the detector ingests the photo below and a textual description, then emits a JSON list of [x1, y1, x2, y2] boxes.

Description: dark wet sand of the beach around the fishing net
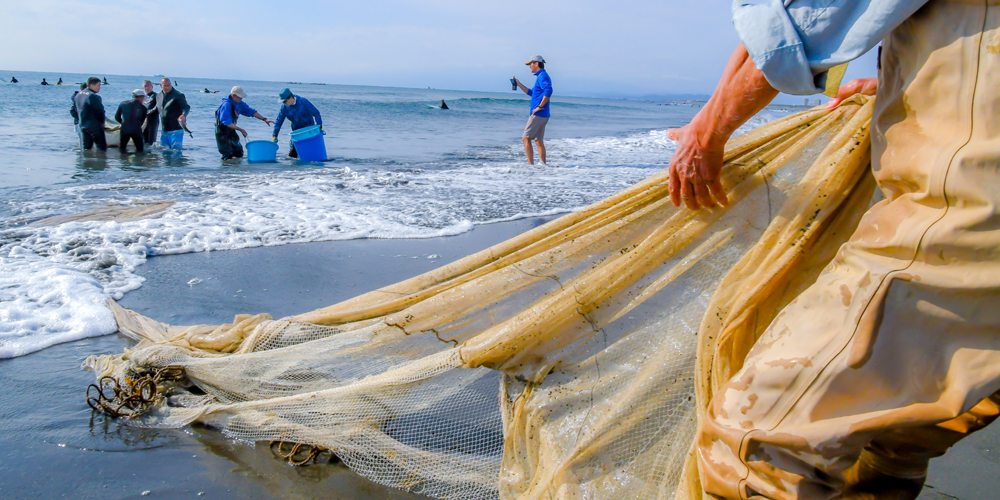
[[0, 213, 1000, 500]]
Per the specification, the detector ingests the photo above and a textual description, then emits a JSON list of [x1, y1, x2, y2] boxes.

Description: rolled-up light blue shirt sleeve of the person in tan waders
[[733, 0, 927, 95]]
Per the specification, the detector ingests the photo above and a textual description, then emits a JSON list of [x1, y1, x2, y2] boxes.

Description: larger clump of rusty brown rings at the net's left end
[[87, 366, 184, 419]]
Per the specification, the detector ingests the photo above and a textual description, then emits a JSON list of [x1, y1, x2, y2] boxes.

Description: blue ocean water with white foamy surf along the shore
[[0, 70, 789, 358]]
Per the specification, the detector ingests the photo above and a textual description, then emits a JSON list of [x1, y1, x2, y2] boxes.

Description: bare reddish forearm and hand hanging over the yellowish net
[[667, 43, 778, 209]]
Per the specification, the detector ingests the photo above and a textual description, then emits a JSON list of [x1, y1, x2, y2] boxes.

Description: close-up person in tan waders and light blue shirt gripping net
[[667, 0, 1000, 500]]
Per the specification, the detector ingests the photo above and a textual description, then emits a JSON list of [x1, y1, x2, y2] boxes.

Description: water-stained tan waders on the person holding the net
[[697, 0, 1000, 500]]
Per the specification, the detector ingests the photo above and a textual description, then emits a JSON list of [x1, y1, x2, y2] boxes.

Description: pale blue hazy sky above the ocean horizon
[[0, 0, 875, 102]]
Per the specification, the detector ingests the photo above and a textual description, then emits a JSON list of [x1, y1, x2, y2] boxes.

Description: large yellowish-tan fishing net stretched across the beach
[[87, 96, 874, 499]]
